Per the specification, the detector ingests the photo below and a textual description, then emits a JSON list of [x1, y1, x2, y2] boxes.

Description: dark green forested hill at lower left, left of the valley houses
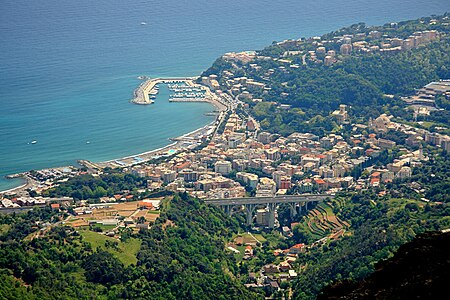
[[0, 195, 258, 299]]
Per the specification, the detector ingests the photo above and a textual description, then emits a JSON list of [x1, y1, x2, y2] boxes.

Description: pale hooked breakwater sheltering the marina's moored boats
[[131, 77, 198, 105]]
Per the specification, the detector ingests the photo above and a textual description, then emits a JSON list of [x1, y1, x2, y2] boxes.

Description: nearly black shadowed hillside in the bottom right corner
[[318, 232, 450, 299]]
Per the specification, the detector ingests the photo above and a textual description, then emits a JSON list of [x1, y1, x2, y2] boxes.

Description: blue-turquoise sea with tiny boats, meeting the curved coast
[[0, 0, 450, 190]]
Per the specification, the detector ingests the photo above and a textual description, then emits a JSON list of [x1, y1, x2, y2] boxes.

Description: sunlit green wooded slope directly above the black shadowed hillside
[[293, 191, 450, 299]]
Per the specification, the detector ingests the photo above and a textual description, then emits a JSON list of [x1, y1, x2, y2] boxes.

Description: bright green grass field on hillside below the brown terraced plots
[[79, 230, 141, 266]]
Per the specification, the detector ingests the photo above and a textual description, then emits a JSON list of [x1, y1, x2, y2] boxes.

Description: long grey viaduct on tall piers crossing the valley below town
[[205, 194, 332, 228]]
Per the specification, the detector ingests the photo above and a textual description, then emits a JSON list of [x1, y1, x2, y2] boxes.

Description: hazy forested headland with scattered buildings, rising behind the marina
[[202, 15, 450, 135]]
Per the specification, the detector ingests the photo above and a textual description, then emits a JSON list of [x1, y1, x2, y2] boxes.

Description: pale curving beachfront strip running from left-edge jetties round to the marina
[[0, 77, 229, 194]]
